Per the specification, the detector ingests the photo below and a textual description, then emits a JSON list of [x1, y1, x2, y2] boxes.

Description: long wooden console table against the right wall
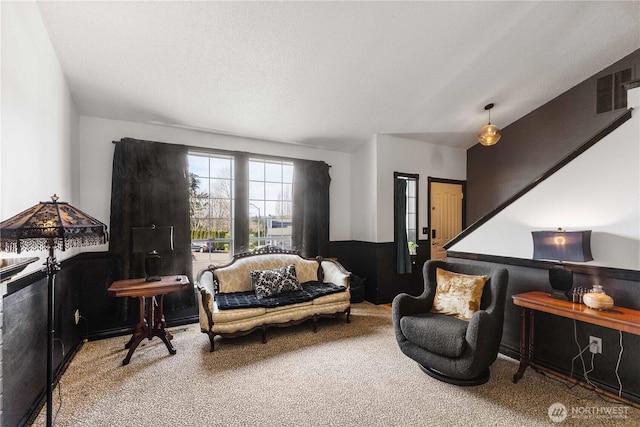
[[512, 291, 640, 408]]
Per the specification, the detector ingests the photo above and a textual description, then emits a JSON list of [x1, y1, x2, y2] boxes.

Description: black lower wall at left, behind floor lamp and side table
[[2, 252, 198, 427]]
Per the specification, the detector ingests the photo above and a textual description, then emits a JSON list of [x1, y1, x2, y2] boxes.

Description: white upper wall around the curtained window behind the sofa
[[78, 116, 351, 241]]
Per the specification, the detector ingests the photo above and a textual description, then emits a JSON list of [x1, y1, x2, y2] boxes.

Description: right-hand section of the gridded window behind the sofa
[[248, 158, 293, 249]]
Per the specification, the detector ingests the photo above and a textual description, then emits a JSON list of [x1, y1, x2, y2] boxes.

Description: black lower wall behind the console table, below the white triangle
[[449, 253, 640, 401]]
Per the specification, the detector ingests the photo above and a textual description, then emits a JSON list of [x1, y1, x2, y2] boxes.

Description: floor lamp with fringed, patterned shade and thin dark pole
[[0, 194, 108, 426]]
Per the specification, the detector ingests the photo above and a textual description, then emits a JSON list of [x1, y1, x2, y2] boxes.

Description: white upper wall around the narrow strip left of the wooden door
[[375, 135, 467, 246]]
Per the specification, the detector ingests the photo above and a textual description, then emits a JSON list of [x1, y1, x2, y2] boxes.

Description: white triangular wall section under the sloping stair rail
[[450, 88, 640, 270]]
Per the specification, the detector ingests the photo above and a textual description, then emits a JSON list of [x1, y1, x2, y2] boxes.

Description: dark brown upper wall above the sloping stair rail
[[466, 49, 640, 224]]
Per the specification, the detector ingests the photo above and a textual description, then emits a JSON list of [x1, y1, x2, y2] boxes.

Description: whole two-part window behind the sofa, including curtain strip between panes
[[188, 151, 293, 272]]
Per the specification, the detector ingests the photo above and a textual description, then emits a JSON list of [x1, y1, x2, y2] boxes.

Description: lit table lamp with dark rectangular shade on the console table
[[531, 229, 593, 300]]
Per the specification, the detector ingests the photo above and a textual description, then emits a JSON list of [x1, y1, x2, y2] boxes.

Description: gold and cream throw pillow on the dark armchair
[[431, 268, 487, 320]]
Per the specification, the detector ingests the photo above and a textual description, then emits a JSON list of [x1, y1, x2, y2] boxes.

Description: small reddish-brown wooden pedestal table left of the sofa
[[107, 275, 189, 366]]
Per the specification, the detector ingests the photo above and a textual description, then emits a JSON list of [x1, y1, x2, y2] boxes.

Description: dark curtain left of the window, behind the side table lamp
[[109, 138, 195, 298]]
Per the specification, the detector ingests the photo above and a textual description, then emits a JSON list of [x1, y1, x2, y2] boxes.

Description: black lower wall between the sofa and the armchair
[[331, 241, 429, 304]]
